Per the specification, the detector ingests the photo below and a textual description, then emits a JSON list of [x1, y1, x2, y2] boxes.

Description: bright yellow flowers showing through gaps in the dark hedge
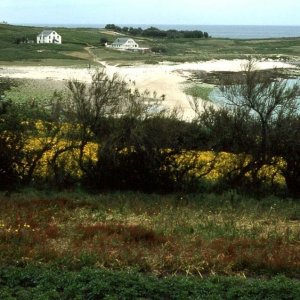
[[21, 121, 285, 185]]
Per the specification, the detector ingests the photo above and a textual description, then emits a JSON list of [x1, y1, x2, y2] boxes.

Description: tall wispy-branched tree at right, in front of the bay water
[[195, 58, 299, 192]]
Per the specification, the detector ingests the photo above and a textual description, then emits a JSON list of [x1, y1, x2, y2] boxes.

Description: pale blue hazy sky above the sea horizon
[[0, 0, 300, 26]]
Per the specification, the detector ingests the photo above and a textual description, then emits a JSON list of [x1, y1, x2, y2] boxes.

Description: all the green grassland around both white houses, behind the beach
[[0, 24, 300, 65]]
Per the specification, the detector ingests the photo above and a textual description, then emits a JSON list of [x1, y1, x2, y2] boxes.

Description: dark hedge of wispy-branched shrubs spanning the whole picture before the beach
[[0, 60, 300, 197]]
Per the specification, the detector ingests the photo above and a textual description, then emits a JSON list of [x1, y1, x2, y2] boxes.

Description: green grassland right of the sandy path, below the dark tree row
[[90, 38, 300, 64]]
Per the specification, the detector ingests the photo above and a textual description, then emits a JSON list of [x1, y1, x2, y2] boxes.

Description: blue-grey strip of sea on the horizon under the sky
[[18, 24, 300, 39]]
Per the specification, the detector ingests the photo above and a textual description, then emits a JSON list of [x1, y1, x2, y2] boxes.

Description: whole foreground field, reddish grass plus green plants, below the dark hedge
[[0, 190, 300, 299]]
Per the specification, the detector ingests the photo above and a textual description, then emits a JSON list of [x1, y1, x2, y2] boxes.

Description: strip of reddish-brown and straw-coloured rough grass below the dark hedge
[[0, 193, 300, 278]]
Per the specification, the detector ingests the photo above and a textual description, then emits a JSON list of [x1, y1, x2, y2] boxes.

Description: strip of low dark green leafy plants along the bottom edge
[[0, 265, 300, 300]]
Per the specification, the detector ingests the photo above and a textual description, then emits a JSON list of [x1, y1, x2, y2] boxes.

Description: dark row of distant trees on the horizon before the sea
[[105, 24, 209, 39]]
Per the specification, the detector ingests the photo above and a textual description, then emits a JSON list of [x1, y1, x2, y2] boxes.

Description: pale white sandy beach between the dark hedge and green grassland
[[0, 60, 294, 119]]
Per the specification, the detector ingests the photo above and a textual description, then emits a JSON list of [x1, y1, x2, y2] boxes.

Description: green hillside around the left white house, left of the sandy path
[[0, 24, 109, 65]]
